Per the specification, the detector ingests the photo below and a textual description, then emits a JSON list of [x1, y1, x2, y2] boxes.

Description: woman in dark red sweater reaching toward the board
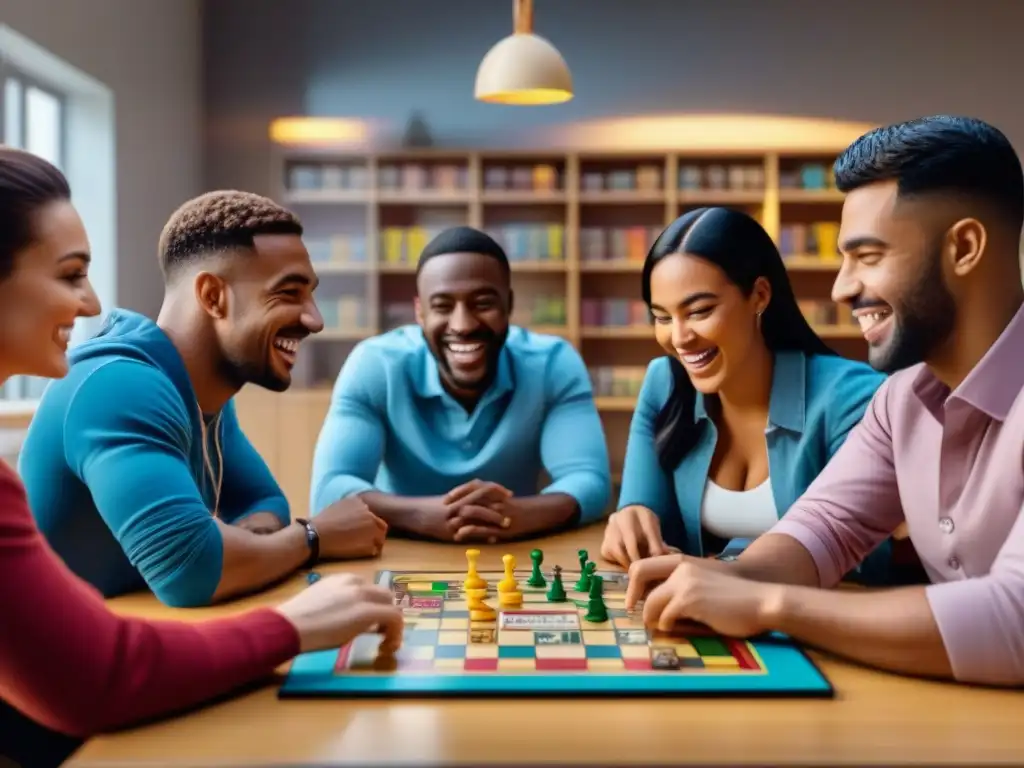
[[0, 147, 402, 763]]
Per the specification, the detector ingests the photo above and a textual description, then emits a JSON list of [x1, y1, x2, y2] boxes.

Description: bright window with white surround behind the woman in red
[[0, 24, 117, 416]]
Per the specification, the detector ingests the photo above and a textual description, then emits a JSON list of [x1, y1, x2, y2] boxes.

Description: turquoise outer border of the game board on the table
[[278, 568, 836, 699]]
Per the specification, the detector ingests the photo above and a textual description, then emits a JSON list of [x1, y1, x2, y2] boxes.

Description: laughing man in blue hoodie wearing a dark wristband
[[19, 191, 386, 606]]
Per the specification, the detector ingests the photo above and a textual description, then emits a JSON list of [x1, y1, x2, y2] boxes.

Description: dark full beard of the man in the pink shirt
[[868, 253, 956, 374]]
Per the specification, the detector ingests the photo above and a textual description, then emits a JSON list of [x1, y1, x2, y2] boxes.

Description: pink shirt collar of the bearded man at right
[[912, 306, 1024, 421]]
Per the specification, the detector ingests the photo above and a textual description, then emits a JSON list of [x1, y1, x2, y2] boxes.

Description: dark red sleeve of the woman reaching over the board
[[0, 462, 299, 737]]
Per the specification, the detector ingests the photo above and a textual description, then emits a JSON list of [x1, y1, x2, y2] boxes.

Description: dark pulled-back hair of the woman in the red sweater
[[0, 146, 71, 281]]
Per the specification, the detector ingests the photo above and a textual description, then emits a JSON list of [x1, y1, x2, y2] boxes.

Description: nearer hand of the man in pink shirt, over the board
[[627, 558, 784, 638]]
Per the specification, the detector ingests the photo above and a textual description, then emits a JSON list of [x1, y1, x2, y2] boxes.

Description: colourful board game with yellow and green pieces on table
[[279, 550, 833, 698]]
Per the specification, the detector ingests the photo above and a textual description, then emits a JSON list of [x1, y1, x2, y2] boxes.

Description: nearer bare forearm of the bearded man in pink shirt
[[764, 585, 952, 679]]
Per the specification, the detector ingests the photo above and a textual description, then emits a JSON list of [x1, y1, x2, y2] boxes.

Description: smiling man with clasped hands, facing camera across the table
[[310, 226, 611, 543]]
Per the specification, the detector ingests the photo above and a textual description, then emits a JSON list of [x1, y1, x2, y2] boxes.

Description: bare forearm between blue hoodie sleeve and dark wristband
[[206, 521, 309, 601]]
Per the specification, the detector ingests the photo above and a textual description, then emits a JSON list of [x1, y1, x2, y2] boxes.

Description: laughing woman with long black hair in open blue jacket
[[601, 208, 889, 581]]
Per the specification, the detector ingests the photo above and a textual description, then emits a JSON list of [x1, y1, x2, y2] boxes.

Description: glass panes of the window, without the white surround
[[0, 67, 65, 401]]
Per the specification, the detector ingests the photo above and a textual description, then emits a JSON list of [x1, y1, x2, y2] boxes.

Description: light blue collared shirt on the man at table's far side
[[310, 326, 611, 523]]
